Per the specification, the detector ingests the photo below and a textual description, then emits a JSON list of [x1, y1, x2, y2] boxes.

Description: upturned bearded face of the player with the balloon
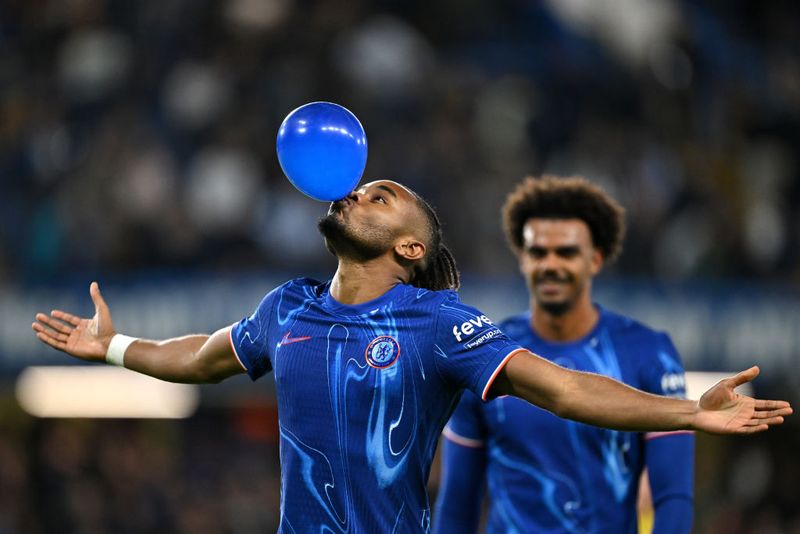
[[317, 180, 419, 260]]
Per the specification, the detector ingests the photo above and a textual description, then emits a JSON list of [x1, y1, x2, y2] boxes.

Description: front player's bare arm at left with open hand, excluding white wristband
[[32, 282, 244, 383]]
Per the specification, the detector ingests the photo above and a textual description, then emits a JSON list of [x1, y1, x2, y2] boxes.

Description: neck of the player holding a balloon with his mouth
[[331, 258, 404, 305]]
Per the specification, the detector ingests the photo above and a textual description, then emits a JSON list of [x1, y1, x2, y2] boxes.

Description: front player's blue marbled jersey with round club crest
[[231, 279, 521, 533]]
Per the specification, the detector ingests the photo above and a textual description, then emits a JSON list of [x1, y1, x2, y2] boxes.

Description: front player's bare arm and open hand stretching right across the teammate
[[490, 352, 792, 434]]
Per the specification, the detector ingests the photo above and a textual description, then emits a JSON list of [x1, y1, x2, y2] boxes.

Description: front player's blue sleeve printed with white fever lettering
[[434, 293, 524, 400]]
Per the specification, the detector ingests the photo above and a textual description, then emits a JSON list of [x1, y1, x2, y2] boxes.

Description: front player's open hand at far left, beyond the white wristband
[[31, 282, 116, 361]]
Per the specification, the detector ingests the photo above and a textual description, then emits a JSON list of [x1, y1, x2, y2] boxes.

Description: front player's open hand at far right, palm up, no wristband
[[695, 366, 792, 434]]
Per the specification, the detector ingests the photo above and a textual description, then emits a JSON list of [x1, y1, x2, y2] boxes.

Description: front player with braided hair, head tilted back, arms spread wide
[[32, 180, 791, 532]]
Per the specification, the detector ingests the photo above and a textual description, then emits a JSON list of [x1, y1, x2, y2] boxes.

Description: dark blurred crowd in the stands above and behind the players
[[0, 0, 800, 284]]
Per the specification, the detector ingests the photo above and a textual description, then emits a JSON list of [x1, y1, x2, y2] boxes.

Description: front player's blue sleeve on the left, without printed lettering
[[231, 289, 278, 380]]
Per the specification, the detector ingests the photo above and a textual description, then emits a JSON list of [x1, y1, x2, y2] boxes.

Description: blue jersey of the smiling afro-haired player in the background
[[444, 308, 685, 534]]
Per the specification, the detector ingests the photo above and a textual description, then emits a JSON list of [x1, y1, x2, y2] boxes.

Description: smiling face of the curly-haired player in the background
[[519, 219, 603, 315]]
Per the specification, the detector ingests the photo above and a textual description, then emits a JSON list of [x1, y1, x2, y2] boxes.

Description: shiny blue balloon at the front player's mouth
[[276, 102, 367, 201]]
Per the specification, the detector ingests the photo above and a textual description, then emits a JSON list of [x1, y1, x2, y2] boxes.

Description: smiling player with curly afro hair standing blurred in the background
[[435, 176, 694, 534]]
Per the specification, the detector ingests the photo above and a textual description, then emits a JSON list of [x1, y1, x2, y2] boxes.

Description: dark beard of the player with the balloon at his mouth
[[317, 214, 392, 261]]
